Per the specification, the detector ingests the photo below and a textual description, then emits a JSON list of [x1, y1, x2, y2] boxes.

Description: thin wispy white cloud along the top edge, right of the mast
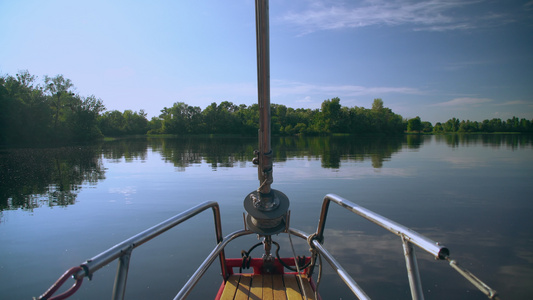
[[282, 0, 504, 34]]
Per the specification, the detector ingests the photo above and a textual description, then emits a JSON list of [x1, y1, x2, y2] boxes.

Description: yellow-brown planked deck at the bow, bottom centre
[[220, 274, 315, 300]]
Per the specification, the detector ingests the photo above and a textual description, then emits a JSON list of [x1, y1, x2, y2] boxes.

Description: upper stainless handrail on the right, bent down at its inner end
[[317, 194, 450, 260]]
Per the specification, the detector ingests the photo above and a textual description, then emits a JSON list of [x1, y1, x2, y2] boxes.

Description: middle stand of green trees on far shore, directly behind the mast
[[140, 98, 405, 135]]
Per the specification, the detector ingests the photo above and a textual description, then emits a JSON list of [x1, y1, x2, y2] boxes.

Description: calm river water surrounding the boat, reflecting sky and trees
[[0, 135, 533, 299]]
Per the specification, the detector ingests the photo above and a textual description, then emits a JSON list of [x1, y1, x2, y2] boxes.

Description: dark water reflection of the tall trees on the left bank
[[0, 146, 105, 211]]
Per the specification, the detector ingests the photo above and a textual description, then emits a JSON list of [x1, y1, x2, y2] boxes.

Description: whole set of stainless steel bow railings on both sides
[[40, 194, 499, 300]]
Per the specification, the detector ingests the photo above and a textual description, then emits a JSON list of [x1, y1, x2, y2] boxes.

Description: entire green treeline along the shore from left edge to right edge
[[0, 71, 533, 145]]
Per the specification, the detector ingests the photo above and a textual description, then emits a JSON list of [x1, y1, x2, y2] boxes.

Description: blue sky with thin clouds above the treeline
[[0, 0, 533, 123]]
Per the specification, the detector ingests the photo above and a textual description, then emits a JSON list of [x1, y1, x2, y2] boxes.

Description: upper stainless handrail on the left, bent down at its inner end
[[75, 201, 225, 278]]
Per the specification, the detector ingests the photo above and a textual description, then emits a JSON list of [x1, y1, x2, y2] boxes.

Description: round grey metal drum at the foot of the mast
[[244, 189, 289, 235]]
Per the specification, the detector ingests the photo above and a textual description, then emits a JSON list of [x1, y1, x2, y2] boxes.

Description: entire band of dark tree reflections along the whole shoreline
[[0, 134, 532, 210]]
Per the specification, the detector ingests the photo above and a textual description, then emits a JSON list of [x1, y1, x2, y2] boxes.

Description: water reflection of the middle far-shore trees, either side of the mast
[[154, 136, 408, 171]]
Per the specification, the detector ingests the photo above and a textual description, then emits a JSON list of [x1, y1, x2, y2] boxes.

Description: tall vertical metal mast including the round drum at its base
[[244, 0, 289, 243]]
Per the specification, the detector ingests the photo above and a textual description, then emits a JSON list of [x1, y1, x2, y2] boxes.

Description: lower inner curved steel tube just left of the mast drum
[[174, 229, 253, 300]]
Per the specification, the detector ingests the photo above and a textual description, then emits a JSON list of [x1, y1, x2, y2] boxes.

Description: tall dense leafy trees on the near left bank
[[0, 71, 105, 144]]
